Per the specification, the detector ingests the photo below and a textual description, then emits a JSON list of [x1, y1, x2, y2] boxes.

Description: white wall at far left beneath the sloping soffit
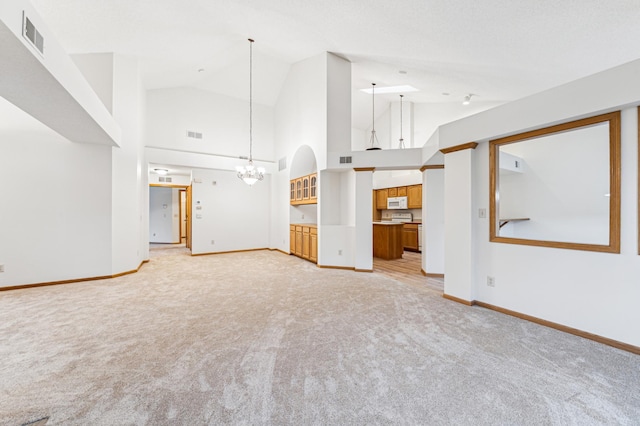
[[0, 98, 111, 287]]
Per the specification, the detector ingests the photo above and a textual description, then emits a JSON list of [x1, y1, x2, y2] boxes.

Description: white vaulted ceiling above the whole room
[[32, 0, 640, 129]]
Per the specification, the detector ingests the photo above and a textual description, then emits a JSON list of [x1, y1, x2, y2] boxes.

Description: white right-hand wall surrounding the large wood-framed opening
[[439, 61, 640, 346]]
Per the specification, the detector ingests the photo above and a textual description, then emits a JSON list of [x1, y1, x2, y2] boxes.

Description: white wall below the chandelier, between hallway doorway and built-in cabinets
[[191, 169, 271, 254]]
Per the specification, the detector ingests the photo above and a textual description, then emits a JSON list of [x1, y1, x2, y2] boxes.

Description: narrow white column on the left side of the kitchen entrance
[[354, 168, 374, 272]]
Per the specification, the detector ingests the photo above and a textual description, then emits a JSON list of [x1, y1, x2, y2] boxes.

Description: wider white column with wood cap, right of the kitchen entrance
[[442, 143, 477, 304]]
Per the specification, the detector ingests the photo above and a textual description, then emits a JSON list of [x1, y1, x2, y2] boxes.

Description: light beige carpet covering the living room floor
[[0, 249, 640, 426]]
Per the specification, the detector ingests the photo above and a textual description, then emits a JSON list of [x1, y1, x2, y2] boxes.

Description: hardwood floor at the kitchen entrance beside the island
[[373, 251, 444, 293]]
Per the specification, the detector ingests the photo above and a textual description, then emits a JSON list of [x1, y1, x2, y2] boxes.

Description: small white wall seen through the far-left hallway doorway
[[149, 187, 180, 243]]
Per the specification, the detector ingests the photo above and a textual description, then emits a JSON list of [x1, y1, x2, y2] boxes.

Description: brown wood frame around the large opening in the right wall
[[489, 111, 620, 254]]
